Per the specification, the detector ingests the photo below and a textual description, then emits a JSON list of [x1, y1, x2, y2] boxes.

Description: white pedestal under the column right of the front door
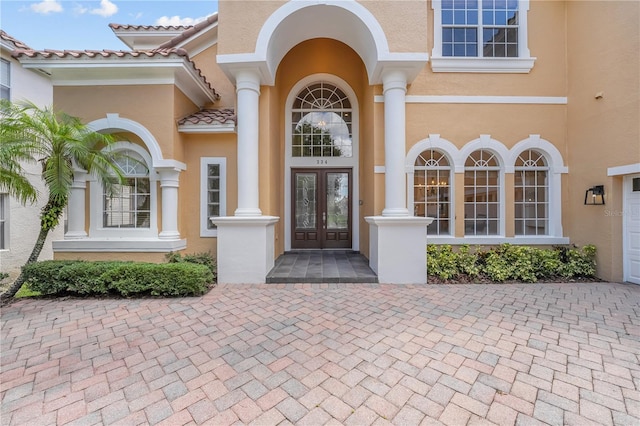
[[365, 216, 433, 284]]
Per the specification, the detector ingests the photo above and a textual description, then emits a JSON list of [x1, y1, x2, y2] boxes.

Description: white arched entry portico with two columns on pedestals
[[213, 1, 430, 283]]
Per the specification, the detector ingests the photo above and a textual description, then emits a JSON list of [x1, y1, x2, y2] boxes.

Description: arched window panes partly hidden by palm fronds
[[103, 151, 151, 228]]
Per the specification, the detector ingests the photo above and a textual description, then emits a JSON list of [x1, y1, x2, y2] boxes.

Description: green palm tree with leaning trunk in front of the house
[[0, 101, 123, 301]]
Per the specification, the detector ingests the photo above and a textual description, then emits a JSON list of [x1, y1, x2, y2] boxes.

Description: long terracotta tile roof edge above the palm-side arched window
[[11, 48, 220, 98]]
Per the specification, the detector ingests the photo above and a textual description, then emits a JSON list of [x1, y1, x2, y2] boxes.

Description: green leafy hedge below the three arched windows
[[427, 244, 596, 282]]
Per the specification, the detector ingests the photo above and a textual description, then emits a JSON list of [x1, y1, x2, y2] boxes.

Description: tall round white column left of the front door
[[235, 71, 262, 216]]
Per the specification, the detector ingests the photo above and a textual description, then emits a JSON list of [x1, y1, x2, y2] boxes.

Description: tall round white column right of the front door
[[382, 71, 409, 216]]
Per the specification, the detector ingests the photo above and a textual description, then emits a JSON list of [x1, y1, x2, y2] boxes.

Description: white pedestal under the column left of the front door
[[211, 216, 280, 284]]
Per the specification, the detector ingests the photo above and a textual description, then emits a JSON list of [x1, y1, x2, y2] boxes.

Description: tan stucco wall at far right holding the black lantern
[[564, 1, 640, 281]]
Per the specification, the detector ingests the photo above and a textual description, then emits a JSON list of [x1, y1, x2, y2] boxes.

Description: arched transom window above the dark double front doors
[[291, 81, 353, 157]]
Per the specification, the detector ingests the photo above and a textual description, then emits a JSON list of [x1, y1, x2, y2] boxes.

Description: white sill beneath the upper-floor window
[[431, 56, 536, 74]]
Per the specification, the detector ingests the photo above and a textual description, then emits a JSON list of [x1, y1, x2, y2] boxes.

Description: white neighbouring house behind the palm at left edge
[[0, 30, 64, 279]]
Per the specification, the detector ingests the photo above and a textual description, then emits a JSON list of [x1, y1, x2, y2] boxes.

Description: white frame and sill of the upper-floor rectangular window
[[431, 0, 536, 73]]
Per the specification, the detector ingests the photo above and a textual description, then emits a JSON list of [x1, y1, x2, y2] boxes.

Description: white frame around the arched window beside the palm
[[89, 142, 158, 239]]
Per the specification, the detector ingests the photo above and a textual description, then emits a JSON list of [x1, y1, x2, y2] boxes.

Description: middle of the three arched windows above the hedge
[[464, 149, 501, 236]]
